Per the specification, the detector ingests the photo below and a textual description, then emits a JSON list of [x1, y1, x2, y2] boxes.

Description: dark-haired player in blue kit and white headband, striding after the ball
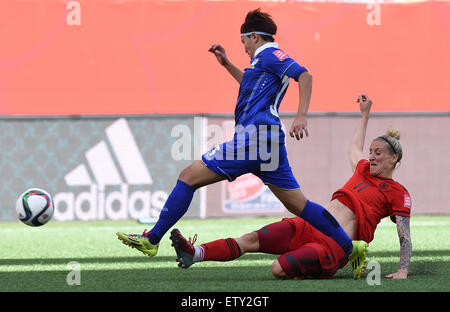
[[117, 9, 367, 276]]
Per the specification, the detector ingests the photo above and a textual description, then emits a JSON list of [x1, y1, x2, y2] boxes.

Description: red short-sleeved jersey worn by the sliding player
[[332, 159, 411, 243]]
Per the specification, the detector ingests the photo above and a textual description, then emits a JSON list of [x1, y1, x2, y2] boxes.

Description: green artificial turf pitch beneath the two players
[[0, 216, 450, 292]]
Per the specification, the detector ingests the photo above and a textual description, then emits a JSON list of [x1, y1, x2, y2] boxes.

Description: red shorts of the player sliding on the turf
[[256, 217, 348, 279]]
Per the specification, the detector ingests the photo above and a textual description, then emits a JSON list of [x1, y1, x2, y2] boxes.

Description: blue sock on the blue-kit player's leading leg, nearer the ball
[[148, 180, 194, 245]]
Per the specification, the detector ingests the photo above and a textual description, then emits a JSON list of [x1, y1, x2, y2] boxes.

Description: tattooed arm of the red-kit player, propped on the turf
[[386, 216, 412, 279]]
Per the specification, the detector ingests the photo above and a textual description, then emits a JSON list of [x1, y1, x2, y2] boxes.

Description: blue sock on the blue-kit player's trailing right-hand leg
[[300, 200, 353, 256]]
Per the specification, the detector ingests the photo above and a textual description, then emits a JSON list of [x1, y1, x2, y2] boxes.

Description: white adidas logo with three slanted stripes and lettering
[[53, 118, 168, 221]]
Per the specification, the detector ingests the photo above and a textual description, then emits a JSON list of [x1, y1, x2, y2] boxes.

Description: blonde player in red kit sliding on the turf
[[171, 95, 412, 279]]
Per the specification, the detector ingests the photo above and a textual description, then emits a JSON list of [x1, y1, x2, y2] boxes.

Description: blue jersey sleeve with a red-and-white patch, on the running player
[[262, 49, 307, 81]]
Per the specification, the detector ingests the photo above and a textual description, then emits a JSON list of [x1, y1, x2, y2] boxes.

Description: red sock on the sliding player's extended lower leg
[[201, 238, 241, 261]]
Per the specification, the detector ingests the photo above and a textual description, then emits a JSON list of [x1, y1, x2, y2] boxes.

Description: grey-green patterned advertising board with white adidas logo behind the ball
[[0, 118, 200, 221]]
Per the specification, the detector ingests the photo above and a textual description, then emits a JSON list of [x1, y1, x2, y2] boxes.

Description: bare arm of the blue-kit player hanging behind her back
[[289, 71, 312, 140]]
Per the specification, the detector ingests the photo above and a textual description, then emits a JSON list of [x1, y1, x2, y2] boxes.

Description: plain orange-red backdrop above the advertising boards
[[0, 0, 450, 115]]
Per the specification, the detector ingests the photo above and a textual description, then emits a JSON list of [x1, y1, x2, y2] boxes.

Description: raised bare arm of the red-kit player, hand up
[[348, 94, 372, 171]]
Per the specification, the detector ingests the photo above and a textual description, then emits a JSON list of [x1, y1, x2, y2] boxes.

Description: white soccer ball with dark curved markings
[[16, 188, 54, 226]]
